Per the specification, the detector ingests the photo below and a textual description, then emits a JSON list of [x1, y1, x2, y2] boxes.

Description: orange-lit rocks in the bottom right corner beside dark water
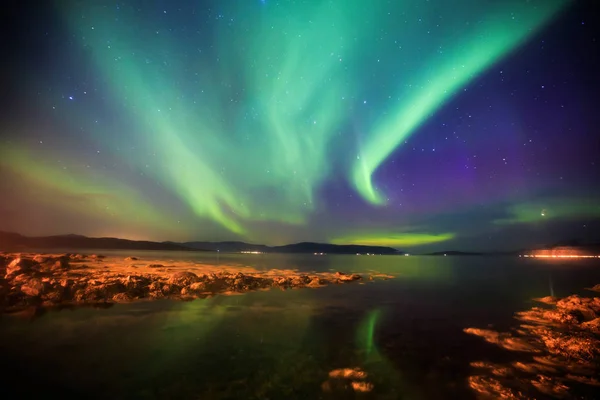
[[465, 285, 600, 399]]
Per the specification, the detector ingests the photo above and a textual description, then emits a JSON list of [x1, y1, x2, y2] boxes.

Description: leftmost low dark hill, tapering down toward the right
[[0, 232, 199, 251]]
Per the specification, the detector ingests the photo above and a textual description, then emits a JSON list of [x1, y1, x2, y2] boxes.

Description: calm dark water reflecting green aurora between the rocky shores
[[0, 255, 600, 399]]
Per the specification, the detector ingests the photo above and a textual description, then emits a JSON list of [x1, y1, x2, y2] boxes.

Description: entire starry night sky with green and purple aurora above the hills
[[0, 0, 600, 251]]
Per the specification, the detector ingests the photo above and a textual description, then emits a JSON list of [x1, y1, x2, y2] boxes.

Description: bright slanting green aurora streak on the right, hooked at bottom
[[351, 0, 565, 204]]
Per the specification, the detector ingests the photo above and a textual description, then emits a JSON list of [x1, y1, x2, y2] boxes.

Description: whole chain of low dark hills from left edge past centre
[[0, 232, 398, 254]]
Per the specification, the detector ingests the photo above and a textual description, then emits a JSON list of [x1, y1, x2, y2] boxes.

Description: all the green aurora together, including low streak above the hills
[[35, 0, 566, 241]]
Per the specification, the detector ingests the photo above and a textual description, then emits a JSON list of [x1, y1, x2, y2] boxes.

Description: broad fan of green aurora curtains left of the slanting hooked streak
[[62, 2, 370, 238]]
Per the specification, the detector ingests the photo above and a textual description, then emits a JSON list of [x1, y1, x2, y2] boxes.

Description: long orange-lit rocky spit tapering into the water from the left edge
[[0, 253, 372, 313]]
